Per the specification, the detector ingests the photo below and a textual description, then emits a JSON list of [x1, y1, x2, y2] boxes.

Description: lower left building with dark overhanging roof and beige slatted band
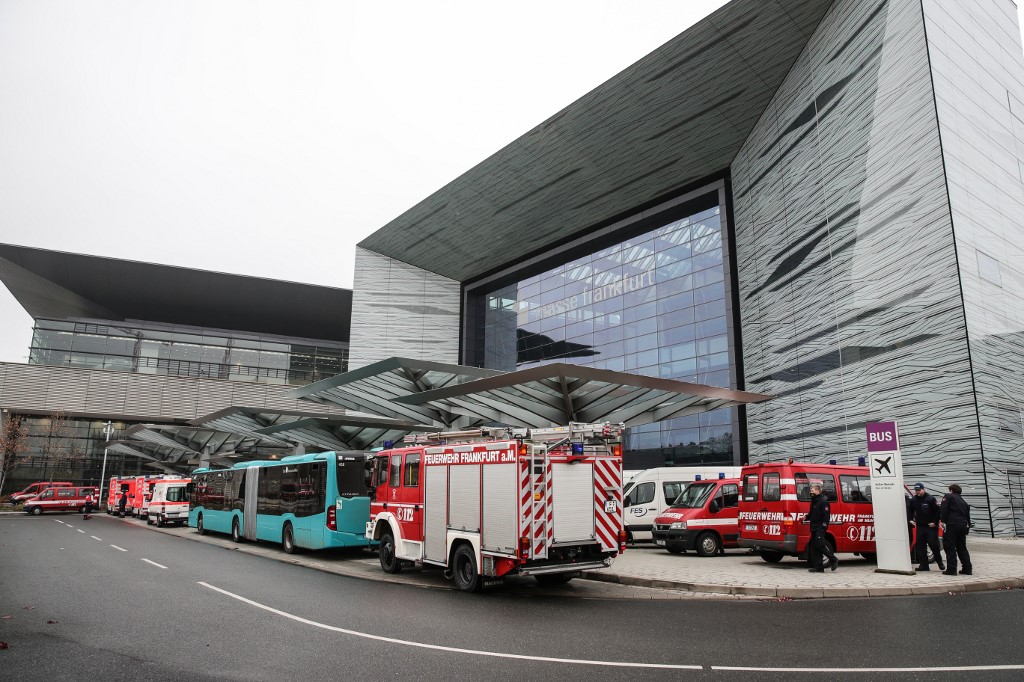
[[0, 245, 351, 493]]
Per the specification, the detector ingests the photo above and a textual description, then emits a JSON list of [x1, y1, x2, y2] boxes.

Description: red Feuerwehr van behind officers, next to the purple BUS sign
[[739, 462, 876, 563]]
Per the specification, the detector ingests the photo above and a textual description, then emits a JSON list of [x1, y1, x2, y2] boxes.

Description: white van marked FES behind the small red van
[[623, 466, 741, 542]]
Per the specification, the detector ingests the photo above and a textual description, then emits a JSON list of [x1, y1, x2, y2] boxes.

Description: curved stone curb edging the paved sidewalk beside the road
[[583, 572, 1024, 599]]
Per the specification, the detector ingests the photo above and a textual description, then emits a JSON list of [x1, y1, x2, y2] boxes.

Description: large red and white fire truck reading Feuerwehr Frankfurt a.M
[[366, 423, 626, 592]]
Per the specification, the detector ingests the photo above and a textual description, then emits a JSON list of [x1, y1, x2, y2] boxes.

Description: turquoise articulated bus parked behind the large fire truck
[[188, 453, 371, 554]]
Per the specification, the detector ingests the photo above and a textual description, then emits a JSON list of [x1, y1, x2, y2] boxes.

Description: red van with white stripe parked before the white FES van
[[652, 478, 739, 556]]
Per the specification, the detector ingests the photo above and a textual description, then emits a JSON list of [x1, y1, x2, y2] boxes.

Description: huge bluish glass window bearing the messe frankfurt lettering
[[466, 207, 734, 468]]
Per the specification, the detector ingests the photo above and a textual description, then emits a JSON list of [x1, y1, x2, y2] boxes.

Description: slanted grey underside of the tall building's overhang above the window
[[359, 0, 833, 282]]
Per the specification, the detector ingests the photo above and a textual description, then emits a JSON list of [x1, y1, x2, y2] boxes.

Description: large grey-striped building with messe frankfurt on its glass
[[349, 0, 1024, 535]]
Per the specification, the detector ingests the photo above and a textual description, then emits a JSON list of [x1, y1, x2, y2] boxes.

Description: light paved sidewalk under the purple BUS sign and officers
[[585, 537, 1024, 599]]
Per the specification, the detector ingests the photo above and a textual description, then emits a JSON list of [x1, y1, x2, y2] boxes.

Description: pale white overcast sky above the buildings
[[0, 0, 1019, 363]]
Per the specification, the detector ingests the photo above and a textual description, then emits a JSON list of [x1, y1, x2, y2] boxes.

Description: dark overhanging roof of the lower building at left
[[0, 244, 352, 342]]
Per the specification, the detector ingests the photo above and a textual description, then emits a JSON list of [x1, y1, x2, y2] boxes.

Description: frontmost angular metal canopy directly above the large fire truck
[[395, 364, 771, 427]]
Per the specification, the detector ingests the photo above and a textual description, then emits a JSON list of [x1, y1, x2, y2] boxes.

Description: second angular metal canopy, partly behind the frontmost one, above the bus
[[291, 357, 501, 426]]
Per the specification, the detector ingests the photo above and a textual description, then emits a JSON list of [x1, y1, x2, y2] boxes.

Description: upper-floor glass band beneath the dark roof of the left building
[[29, 318, 348, 385]]
